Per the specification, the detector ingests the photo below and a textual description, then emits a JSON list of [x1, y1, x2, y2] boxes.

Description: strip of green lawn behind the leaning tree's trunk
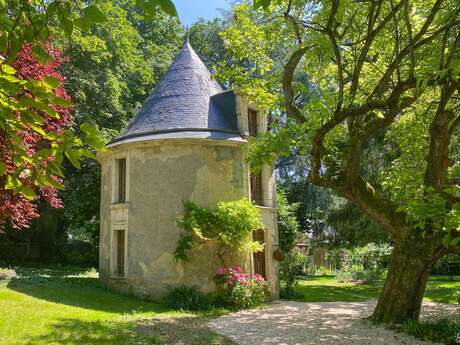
[[294, 276, 460, 303]]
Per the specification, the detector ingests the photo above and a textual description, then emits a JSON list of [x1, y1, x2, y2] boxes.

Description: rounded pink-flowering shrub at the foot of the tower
[[214, 267, 267, 309]]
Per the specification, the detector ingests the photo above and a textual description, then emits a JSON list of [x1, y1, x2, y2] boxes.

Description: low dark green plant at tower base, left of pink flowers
[[165, 285, 216, 311]]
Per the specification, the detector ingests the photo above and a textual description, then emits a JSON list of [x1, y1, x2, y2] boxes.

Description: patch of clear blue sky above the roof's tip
[[173, 0, 233, 26]]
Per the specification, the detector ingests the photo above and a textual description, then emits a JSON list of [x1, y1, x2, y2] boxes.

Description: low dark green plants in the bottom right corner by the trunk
[[401, 319, 460, 345]]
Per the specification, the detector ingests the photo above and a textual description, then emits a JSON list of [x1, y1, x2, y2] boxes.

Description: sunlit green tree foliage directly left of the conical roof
[[58, 0, 182, 131]]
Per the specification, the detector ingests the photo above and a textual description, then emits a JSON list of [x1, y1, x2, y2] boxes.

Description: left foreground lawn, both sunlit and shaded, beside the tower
[[0, 268, 232, 345]]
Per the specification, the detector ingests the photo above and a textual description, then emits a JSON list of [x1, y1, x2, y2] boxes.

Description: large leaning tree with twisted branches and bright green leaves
[[224, 0, 460, 323]]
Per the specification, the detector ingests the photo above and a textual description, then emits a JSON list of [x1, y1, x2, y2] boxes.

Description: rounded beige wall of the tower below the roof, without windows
[[100, 140, 260, 298]]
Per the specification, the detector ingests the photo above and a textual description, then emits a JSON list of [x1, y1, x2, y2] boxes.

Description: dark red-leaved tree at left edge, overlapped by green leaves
[[0, 44, 100, 228]]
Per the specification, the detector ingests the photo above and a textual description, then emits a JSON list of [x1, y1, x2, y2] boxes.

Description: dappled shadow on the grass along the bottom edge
[[27, 317, 234, 345]]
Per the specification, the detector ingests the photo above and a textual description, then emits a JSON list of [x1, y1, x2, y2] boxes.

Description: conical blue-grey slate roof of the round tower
[[110, 40, 241, 146]]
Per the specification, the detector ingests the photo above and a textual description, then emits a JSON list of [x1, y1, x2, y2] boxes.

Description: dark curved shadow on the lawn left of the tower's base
[[7, 269, 169, 314]]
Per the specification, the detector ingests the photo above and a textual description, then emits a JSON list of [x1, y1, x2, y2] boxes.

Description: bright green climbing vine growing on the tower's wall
[[175, 198, 263, 261]]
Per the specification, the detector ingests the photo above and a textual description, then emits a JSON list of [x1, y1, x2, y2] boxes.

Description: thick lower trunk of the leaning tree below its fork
[[371, 236, 443, 324]]
